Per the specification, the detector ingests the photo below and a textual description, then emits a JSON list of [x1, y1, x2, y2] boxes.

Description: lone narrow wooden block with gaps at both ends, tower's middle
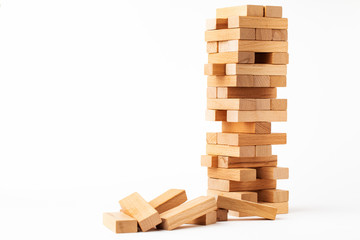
[[222, 122, 271, 134]]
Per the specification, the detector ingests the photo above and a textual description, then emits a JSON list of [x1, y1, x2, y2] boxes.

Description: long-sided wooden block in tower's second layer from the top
[[229, 16, 288, 29]]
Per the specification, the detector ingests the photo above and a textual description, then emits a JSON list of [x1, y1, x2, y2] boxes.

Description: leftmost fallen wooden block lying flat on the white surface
[[103, 212, 137, 233]]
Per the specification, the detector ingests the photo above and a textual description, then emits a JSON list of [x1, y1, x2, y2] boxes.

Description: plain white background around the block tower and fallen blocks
[[0, 0, 360, 239]]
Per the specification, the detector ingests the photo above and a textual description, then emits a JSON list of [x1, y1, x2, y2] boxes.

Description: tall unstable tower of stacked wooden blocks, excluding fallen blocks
[[201, 5, 289, 216]]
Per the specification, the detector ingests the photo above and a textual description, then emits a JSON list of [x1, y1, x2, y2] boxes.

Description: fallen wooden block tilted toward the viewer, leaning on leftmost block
[[119, 192, 161, 232]]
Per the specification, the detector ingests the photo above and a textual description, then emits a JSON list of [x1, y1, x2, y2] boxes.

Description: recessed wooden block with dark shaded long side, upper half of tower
[[216, 87, 276, 98]]
